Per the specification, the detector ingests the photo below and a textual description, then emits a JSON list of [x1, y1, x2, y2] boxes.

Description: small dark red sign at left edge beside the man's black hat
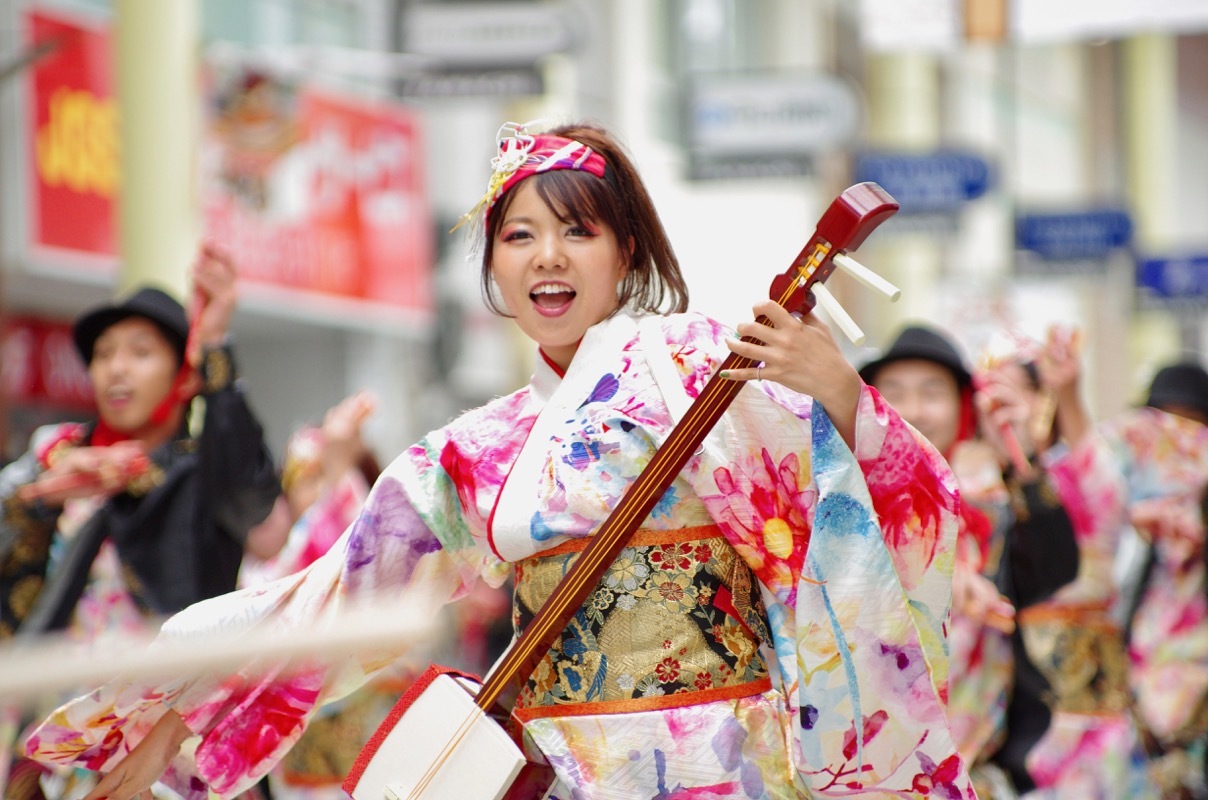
[[0, 318, 95, 411]]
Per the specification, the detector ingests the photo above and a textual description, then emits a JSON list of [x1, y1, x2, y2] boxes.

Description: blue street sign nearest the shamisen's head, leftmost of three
[[854, 150, 991, 214]]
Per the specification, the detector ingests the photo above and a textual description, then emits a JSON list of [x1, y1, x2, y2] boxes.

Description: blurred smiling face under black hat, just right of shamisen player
[[873, 359, 960, 453]]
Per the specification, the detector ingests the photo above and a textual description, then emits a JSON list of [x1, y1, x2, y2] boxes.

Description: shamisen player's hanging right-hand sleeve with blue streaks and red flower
[[795, 390, 974, 798]]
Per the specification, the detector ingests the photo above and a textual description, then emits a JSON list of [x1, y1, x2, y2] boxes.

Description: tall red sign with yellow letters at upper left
[[28, 11, 121, 257]]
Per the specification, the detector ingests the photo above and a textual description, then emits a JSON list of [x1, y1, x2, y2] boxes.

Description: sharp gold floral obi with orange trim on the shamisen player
[[512, 526, 771, 721]]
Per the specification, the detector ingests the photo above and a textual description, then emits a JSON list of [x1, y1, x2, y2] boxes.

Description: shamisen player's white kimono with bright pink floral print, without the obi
[[29, 314, 974, 800]]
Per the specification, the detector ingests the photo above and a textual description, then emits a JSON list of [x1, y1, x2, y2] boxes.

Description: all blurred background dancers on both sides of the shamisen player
[[0, 249, 1208, 799]]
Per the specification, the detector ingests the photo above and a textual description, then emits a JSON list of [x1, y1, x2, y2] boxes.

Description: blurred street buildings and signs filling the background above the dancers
[[0, 0, 1208, 464]]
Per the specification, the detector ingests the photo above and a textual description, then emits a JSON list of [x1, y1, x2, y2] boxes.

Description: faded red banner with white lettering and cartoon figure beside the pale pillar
[[203, 73, 432, 312]]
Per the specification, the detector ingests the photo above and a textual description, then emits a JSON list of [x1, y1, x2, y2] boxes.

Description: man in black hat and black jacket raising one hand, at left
[[0, 249, 279, 639]]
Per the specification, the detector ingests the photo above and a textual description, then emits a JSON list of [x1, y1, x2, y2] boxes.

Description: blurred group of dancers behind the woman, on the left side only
[[0, 248, 511, 799]]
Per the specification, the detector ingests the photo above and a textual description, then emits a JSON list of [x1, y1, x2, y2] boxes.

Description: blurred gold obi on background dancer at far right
[[1018, 603, 1131, 714]]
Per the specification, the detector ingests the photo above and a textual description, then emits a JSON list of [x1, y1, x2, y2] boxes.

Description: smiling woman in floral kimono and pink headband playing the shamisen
[[28, 119, 975, 800]]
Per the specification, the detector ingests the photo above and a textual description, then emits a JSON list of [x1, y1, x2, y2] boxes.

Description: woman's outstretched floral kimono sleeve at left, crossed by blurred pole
[[27, 432, 504, 798]]
